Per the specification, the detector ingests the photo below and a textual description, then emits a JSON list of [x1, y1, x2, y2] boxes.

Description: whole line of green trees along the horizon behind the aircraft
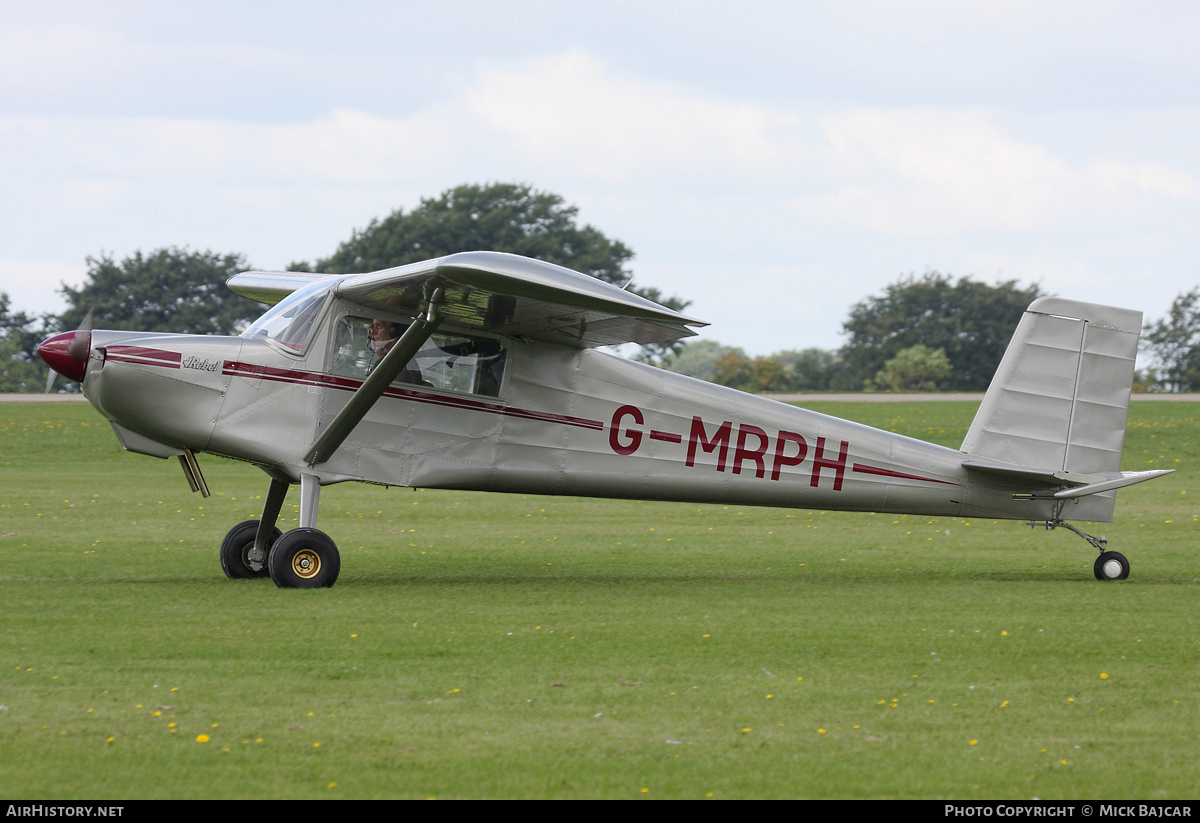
[[0, 184, 1200, 392]]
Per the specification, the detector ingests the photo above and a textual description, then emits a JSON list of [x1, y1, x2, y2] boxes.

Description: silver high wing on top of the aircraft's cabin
[[228, 252, 707, 348]]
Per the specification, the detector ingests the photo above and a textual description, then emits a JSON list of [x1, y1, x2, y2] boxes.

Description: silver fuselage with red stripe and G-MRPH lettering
[[72, 321, 1049, 518]]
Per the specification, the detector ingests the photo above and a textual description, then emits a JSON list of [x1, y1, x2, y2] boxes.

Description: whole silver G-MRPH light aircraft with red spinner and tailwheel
[[38, 252, 1168, 588]]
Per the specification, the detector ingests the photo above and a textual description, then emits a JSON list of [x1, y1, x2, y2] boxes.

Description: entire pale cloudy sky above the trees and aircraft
[[0, 0, 1200, 354]]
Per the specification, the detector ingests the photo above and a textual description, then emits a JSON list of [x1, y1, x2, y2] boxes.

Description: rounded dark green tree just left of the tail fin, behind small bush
[[841, 272, 1042, 391]]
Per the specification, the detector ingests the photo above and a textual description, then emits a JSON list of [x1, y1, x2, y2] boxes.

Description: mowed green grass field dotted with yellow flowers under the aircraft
[[0, 402, 1200, 799]]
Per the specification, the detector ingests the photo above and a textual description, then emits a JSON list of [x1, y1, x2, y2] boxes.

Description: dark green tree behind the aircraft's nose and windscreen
[[59, 248, 263, 335]]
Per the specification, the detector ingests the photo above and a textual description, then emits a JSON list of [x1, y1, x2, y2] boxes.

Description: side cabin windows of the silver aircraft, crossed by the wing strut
[[330, 317, 505, 397]]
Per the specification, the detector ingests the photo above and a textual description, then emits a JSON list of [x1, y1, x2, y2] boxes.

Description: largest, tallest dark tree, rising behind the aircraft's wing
[[302, 184, 689, 362]]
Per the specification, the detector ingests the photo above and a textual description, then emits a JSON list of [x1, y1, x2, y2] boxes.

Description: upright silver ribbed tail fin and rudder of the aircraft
[[962, 298, 1141, 519]]
